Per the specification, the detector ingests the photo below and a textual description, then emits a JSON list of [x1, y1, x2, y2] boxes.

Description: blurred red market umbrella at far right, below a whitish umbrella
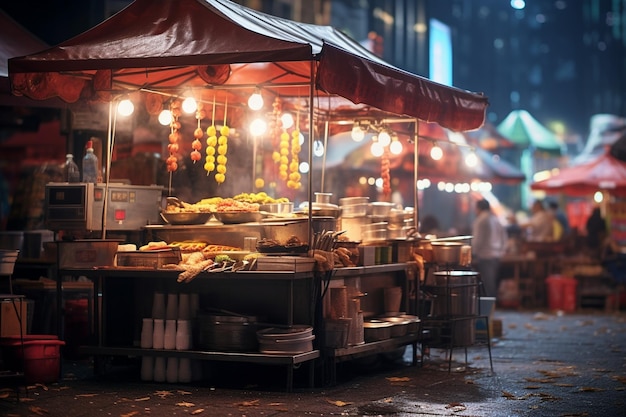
[[530, 152, 626, 196]]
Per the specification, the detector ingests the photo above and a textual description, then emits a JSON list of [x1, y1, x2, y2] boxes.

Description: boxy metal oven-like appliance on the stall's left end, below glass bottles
[[44, 183, 163, 231]]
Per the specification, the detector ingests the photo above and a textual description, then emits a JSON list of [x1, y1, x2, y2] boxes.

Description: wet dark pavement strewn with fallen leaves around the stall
[[0, 310, 626, 417]]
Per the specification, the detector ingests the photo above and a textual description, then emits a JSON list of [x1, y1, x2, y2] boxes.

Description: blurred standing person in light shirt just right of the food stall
[[472, 199, 508, 297]]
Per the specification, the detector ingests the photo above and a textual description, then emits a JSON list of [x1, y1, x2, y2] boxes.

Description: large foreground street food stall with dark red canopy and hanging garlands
[[9, 0, 487, 389]]
